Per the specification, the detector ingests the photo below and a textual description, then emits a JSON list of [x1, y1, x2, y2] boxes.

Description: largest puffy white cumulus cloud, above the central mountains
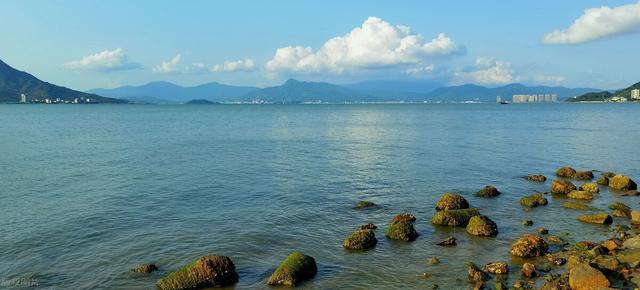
[[266, 17, 465, 74]]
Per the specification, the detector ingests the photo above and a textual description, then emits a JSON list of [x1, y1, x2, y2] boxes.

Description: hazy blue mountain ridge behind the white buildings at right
[[426, 84, 598, 102]]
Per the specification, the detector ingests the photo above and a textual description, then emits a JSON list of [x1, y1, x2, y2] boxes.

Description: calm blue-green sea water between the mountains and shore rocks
[[0, 104, 640, 289]]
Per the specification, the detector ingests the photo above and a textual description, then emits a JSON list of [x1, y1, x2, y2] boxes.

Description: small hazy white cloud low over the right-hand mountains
[[453, 57, 520, 85]]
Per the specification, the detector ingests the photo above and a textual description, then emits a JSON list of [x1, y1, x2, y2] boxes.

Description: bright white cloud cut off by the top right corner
[[543, 1, 640, 44]]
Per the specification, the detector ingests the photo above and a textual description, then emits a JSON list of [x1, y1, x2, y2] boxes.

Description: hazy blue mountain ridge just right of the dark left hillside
[[89, 81, 257, 103]]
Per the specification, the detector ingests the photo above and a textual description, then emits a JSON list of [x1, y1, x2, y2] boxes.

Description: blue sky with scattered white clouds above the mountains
[[0, 0, 640, 90]]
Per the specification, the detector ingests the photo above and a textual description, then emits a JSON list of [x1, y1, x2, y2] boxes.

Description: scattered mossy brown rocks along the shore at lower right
[[132, 167, 640, 290]]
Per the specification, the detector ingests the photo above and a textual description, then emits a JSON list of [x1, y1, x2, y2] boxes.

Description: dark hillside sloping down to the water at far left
[[0, 60, 126, 103]]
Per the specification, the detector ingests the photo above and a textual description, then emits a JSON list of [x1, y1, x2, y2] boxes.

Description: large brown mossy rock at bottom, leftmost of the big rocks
[[156, 255, 238, 290]]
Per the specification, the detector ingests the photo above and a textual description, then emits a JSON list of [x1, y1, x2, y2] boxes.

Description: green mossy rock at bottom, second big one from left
[[267, 252, 318, 286]]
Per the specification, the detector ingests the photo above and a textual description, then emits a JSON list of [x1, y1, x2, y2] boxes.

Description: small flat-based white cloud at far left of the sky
[[64, 48, 142, 71]]
